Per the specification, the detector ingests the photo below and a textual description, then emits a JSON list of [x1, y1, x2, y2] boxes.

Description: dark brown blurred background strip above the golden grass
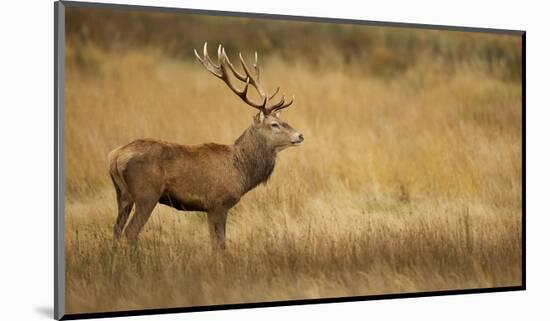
[[66, 8, 521, 81]]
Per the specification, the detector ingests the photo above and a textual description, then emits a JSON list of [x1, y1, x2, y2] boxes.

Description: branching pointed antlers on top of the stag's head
[[195, 42, 294, 115]]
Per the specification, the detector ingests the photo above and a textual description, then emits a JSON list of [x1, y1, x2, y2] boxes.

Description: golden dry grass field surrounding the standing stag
[[65, 33, 522, 313]]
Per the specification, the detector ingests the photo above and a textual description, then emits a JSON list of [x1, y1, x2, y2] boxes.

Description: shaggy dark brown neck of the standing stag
[[234, 127, 277, 193]]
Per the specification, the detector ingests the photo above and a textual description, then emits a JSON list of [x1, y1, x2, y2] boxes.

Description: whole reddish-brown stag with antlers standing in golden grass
[[109, 43, 304, 248]]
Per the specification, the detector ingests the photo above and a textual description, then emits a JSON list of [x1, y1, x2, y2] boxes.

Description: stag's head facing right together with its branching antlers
[[195, 42, 304, 150]]
